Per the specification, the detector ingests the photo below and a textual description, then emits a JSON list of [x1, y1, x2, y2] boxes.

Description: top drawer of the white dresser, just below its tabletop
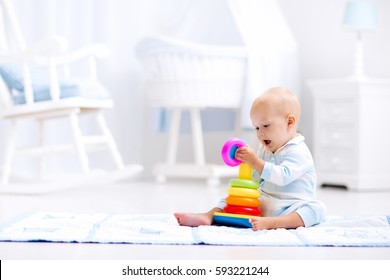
[[318, 98, 355, 124]]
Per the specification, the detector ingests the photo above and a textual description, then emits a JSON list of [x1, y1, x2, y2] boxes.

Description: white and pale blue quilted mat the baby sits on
[[0, 212, 390, 247]]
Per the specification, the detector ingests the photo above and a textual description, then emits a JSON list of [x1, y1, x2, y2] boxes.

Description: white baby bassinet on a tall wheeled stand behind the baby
[[136, 37, 247, 184]]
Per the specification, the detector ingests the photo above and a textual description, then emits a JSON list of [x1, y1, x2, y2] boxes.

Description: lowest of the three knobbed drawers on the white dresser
[[315, 149, 356, 173]]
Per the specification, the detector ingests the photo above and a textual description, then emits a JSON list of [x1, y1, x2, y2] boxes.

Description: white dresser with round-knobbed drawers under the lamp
[[307, 79, 390, 191]]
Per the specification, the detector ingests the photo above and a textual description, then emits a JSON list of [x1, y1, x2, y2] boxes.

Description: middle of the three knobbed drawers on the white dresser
[[317, 126, 356, 148]]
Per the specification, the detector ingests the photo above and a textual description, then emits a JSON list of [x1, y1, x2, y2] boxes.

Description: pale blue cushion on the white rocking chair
[[0, 63, 110, 104]]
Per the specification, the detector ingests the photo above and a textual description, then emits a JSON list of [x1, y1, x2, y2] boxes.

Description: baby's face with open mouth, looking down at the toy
[[250, 105, 291, 153]]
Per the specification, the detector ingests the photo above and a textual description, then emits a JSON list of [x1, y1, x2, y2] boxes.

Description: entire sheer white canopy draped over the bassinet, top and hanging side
[[154, 0, 300, 125]]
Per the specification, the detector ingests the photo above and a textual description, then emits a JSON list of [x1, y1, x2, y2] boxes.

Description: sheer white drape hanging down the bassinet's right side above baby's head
[[229, 0, 300, 127]]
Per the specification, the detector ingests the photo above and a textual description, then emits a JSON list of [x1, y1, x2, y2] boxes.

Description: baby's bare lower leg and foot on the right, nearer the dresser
[[250, 212, 305, 230]]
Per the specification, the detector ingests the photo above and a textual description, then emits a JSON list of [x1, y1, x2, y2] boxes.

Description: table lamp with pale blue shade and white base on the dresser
[[343, 0, 378, 79]]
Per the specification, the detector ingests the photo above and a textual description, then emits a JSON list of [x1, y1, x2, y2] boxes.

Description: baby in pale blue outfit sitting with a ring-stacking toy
[[175, 87, 325, 230]]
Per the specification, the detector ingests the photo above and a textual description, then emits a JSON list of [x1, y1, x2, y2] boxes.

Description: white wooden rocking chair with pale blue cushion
[[0, 0, 142, 190]]
